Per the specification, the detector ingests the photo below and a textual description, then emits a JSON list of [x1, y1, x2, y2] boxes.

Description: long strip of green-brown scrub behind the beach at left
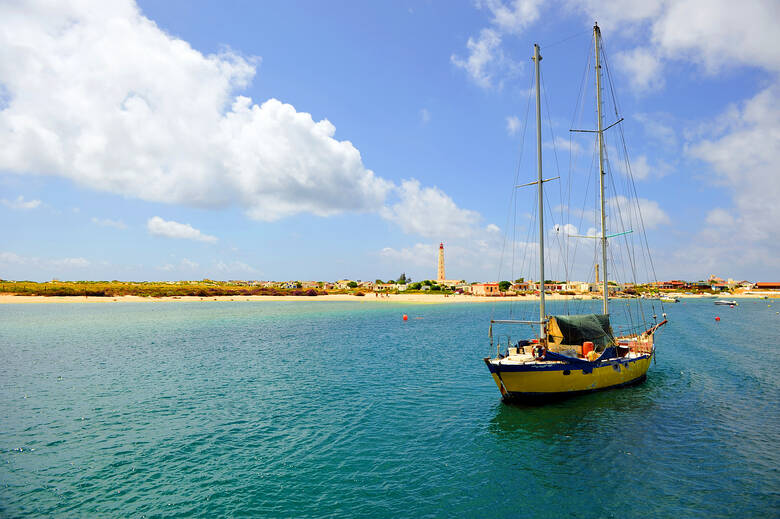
[[0, 279, 328, 297]]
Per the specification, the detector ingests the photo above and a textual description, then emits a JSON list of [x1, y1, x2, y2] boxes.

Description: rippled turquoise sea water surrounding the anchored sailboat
[[0, 299, 780, 518]]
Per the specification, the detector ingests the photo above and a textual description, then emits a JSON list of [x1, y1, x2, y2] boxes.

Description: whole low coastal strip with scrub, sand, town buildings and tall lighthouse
[[0, 243, 780, 300]]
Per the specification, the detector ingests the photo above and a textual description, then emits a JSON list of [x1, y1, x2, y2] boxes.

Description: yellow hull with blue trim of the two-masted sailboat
[[485, 354, 652, 398]]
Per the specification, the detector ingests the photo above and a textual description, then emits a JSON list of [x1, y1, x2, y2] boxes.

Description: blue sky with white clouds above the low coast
[[0, 0, 780, 281]]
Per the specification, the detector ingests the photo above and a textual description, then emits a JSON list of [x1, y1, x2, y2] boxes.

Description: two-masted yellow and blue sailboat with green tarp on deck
[[484, 23, 667, 401]]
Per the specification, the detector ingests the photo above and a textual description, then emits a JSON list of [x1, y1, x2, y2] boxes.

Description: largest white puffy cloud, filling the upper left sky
[[0, 0, 391, 221]]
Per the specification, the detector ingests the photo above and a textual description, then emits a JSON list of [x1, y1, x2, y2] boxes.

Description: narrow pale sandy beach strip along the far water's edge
[[0, 292, 780, 304]]
